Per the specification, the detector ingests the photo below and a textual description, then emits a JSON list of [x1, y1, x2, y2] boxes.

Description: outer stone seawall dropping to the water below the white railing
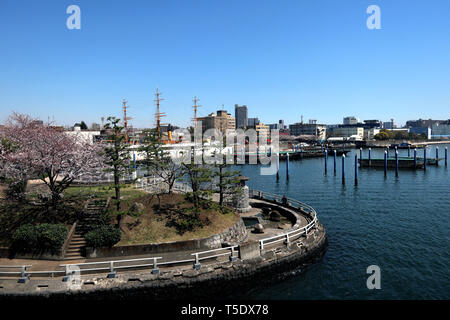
[[0, 223, 328, 300]]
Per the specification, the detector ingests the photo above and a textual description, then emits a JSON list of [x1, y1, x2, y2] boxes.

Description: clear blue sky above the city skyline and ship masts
[[0, 0, 450, 127]]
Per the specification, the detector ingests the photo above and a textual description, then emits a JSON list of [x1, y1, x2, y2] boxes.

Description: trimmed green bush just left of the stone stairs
[[12, 223, 67, 254]]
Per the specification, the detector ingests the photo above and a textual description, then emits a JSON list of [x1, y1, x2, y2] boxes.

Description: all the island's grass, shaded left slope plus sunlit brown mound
[[0, 185, 239, 246]]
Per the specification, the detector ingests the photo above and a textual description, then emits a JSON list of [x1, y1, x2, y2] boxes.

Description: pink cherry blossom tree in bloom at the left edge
[[0, 113, 103, 209]]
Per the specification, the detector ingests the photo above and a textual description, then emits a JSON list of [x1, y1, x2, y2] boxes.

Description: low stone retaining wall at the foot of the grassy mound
[[86, 218, 248, 258]]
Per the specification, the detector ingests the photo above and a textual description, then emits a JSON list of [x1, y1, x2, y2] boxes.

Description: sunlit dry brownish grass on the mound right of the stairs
[[65, 185, 239, 245]]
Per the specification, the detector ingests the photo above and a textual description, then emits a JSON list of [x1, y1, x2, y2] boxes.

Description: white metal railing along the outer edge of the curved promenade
[[0, 190, 318, 278]]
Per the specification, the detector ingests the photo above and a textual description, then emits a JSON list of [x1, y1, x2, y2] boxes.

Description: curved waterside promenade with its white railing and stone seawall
[[0, 190, 327, 299]]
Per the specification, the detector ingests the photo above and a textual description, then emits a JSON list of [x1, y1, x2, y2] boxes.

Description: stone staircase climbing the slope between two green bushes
[[64, 199, 108, 260]]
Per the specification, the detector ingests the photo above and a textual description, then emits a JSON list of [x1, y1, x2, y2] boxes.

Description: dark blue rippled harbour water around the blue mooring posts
[[239, 145, 450, 299]]
